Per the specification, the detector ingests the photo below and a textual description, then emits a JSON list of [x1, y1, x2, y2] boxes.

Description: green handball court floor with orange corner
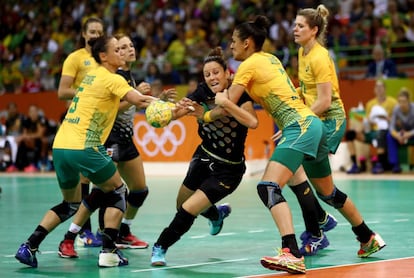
[[0, 173, 414, 278]]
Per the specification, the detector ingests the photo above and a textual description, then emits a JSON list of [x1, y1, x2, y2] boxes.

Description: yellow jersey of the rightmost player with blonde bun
[[298, 43, 346, 120]]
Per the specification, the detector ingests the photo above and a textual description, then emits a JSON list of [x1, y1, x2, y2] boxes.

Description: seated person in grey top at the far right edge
[[387, 88, 414, 173]]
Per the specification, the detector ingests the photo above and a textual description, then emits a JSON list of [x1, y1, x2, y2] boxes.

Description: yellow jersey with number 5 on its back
[[53, 66, 133, 150]]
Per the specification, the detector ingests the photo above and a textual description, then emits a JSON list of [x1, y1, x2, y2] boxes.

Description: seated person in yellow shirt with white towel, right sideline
[[345, 80, 397, 174]]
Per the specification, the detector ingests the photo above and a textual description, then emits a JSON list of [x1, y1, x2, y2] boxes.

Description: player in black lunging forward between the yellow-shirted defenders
[[151, 48, 258, 266]]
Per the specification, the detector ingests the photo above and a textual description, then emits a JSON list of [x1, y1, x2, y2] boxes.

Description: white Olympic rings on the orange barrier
[[134, 120, 186, 157]]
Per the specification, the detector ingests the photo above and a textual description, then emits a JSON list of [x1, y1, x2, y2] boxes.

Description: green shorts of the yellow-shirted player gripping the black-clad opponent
[[270, 116, 329, 173]]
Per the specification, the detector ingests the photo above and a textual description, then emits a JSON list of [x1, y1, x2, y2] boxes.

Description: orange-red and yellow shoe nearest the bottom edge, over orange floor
[[260, 248, 306, 274]]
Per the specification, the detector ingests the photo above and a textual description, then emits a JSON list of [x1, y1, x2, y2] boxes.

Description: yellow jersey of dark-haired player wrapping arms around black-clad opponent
[[233, 51, 315, 129]]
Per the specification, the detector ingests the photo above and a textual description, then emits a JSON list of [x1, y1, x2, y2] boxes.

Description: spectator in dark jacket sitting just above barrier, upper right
[[365, 44, 398, 79]]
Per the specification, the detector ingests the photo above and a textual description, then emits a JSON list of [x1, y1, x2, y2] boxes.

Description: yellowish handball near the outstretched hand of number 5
[[145, 99, 175, 128]]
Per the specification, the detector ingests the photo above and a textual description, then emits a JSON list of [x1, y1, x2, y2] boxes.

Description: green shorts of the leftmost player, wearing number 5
[[53, 145, 116, 189]]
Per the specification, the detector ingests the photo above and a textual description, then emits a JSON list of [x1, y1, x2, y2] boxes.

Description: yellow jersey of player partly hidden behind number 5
[[62, 48, 98, 89]]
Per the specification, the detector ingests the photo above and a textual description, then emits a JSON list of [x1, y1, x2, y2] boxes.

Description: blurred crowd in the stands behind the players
[[0, 0, 414, 93]]
